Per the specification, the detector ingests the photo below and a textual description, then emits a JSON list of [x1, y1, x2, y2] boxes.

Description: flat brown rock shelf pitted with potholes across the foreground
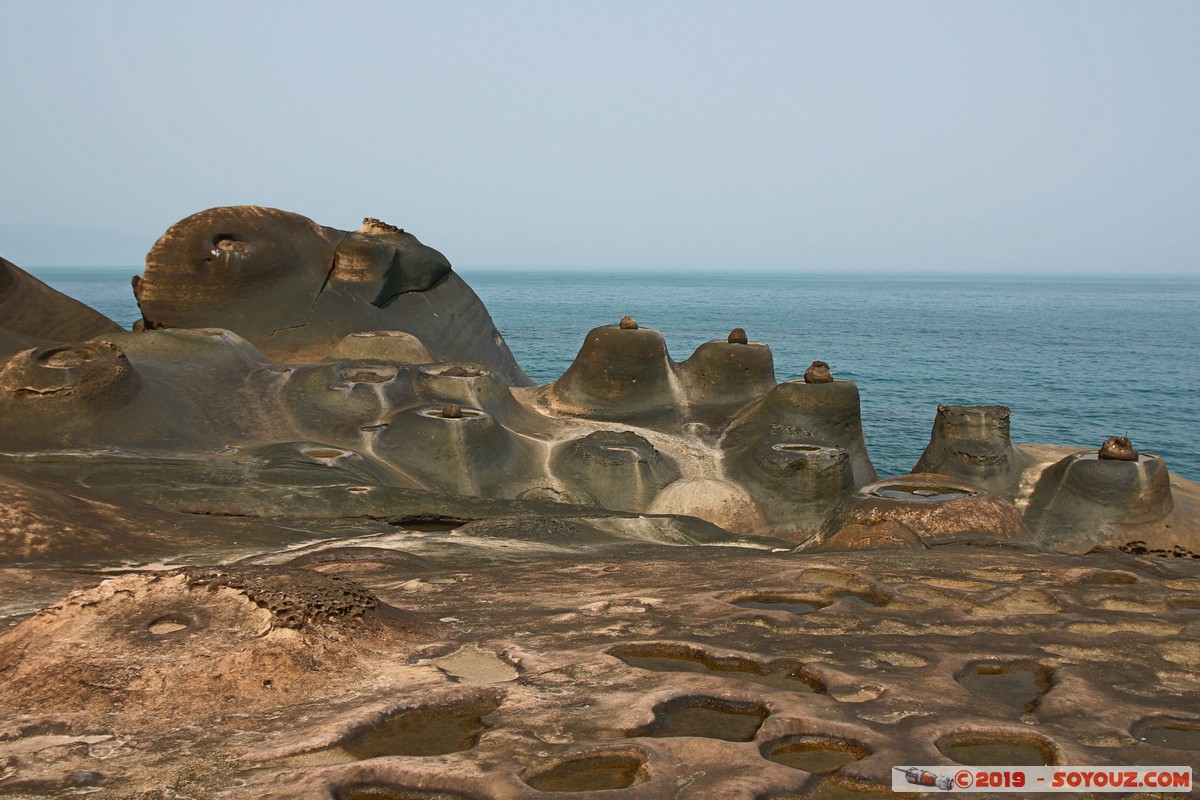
[[0, 542, 1200, 800]]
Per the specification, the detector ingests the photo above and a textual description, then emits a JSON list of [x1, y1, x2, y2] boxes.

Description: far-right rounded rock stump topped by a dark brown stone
[[1025, 437, 1200, 552]]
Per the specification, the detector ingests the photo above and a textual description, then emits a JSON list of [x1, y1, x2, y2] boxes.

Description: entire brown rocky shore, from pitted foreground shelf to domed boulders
[[0, 207, 1200, 800]]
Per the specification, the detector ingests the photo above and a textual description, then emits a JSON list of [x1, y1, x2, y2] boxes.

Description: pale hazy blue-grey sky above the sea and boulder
[[0, 0, 1200, 277]]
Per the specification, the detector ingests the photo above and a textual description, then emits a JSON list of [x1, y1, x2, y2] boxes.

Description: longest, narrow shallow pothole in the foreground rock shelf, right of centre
[[608, 644, 824, 692]]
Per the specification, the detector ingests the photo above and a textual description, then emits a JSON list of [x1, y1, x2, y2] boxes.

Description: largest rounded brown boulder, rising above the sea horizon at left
[[134, 206, 530, 385]]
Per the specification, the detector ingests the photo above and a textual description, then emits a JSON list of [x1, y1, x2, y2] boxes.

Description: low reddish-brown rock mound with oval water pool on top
[[802, 474, 1038, 551]]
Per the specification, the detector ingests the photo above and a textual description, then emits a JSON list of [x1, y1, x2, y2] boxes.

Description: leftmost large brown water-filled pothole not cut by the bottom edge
[[336, 700, 498, 759]]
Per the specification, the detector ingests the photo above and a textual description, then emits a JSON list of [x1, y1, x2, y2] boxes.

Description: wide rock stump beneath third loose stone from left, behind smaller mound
[[722, 380, 878, 486]]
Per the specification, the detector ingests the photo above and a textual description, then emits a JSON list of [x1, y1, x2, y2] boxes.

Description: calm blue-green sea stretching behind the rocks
[[21, 266, 1200, 480]]
